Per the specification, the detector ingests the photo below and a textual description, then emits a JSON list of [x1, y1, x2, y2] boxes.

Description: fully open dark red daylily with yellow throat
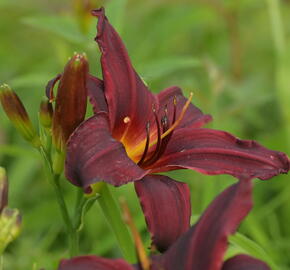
[[65, 6, 289, 251]]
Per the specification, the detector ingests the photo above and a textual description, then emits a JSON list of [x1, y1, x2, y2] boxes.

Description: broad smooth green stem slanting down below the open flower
[[98, 183, 136, 263]]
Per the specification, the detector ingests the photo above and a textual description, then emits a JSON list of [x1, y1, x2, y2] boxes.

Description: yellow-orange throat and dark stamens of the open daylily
[[124, 93, 193, 168]]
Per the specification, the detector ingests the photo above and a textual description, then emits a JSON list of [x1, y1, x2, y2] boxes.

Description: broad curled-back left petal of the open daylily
[[65, 113, 146, 188]]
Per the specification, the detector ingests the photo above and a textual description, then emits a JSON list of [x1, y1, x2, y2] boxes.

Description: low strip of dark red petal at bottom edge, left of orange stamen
[[58, 256, 134, 270]]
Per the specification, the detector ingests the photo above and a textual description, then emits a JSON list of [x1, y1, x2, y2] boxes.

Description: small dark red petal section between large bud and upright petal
[[87, 75, 108, 113]]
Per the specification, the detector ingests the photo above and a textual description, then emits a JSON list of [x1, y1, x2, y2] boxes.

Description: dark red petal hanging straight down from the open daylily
[[135, 175, 191, 252]]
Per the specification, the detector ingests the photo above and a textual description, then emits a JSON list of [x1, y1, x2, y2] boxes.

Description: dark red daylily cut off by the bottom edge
[[58, 179, 270, 270]]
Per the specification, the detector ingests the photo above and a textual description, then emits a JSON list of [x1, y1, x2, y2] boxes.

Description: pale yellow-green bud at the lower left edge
[[0, 208, 21, 254]]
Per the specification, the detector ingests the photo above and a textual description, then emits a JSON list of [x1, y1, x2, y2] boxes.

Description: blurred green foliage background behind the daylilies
[[0, 0, 290, 270]]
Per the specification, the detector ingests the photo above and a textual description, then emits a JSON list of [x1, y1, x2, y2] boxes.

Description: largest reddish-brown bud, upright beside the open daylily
[[52, 54, 88, 150]]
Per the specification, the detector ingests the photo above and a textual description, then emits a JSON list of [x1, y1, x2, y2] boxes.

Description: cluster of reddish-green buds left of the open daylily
[[0, 53, 89, 174]]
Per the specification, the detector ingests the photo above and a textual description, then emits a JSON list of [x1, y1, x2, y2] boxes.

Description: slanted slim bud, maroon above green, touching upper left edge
[[0, 84, 40, 147]]
